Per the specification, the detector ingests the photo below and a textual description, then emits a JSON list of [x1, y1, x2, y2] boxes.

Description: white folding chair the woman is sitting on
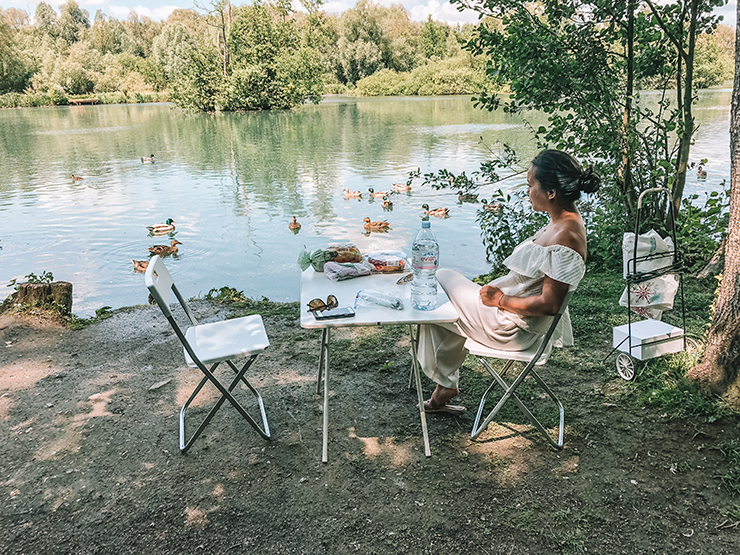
[[465, 291, 573, 449]]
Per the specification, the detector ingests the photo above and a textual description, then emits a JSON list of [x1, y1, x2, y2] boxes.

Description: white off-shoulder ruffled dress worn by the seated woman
[[418, 230, 586, 389]]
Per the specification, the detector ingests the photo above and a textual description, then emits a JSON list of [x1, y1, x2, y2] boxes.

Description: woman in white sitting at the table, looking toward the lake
[[418, 150, 601, 413]]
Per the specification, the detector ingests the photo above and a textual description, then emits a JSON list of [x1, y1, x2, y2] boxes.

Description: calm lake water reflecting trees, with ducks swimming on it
[[0, 90, 731, 316]]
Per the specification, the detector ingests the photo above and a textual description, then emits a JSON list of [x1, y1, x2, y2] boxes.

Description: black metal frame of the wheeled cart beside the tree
[[602, 187, 697, 381]]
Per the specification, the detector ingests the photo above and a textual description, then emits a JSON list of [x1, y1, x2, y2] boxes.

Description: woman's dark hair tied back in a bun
[[532, 149, 601, 202]]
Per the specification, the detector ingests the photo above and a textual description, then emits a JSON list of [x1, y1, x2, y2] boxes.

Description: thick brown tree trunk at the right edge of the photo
[[689, 2, 740, 409]]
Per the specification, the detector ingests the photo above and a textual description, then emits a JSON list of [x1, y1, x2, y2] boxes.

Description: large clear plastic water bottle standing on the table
[[411, 221, 439, 310]]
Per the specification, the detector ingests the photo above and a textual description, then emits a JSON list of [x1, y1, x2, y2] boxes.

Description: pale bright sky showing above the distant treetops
[[0, 0, 737, 27]]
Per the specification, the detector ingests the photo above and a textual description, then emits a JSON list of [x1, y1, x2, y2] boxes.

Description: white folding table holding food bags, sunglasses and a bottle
[[301, 267, 458, 462]]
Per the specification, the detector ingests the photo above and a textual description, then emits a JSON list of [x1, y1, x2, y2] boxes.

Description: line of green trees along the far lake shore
[[0, 0, 734, 111]]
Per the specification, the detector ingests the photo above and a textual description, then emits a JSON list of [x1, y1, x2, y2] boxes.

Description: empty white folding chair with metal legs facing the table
[[144, 256, 270, 453]]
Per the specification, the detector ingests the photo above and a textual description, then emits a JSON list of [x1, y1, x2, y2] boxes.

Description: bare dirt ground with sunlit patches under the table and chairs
[[0, 301, 740, 555]]
